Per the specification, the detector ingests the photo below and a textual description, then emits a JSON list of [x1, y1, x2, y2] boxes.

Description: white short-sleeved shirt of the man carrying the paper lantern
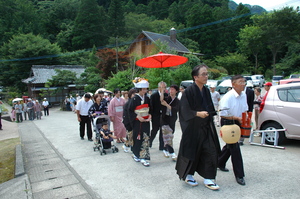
[[220, 89, 248, 117]]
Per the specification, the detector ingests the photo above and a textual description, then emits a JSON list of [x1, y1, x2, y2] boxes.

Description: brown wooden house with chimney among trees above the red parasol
[[127, 28, 199, 56]]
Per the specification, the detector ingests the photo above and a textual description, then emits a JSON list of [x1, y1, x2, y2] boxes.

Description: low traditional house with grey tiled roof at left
[[22, 65, 85, 104]]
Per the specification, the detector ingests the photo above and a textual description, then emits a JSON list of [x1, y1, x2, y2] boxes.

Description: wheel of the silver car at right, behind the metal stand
[[262, 122, 286, 145]]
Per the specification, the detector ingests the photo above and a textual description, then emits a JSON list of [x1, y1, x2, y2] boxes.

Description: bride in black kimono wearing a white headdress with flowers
[[128, 77, 151, 167]]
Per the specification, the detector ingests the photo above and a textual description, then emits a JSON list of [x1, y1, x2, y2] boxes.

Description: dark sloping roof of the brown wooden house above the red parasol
[[142, 31, 190, 53]]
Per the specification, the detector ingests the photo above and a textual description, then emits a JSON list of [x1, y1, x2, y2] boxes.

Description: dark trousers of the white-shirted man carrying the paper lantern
[[218, 119, 245, 178]]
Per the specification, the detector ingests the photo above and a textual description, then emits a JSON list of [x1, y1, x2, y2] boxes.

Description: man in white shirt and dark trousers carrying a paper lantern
[[218, 75, 248, 185]]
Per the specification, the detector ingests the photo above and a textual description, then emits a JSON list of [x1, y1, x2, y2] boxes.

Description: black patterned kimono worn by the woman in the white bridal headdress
[[128, 95, 150, 160]]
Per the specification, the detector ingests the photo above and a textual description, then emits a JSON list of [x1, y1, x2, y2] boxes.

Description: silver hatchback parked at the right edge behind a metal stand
[[258, 83, 300, 145]]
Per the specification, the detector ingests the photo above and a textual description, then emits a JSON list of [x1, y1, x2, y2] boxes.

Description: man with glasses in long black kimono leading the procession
[[176, 65, 220, 190]]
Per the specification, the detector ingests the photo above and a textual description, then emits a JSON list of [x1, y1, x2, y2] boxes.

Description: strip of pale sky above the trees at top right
[[233, 0, 300, 11]]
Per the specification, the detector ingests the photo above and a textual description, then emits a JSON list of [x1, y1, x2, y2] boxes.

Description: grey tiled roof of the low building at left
[[22, 65, 85, 84]]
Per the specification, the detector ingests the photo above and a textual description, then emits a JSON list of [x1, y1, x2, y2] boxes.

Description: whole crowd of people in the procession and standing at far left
[[0, 64, 272, 190]]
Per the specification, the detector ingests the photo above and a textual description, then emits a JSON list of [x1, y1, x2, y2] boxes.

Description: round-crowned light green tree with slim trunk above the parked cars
[[237, 26, 264, 73]]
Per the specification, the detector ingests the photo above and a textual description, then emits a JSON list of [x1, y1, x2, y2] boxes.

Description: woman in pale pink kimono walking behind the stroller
[[108, 89, 126, 143]]
